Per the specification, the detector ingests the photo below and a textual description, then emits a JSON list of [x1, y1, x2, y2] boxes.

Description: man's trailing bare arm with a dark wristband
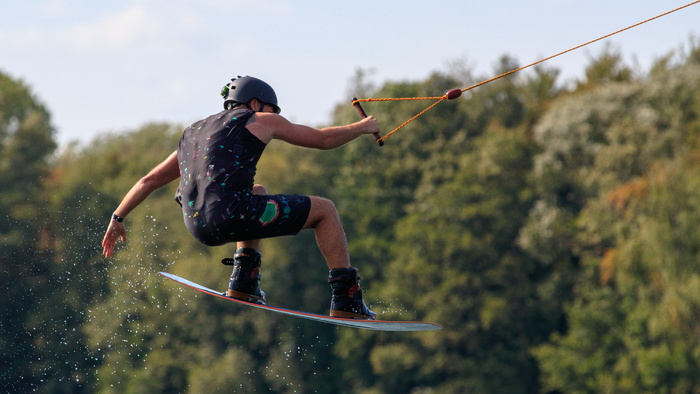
[[102, 151, 180, 257]]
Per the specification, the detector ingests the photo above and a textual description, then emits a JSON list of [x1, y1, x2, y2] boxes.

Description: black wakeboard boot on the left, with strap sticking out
[[222, 248, 265, 305]]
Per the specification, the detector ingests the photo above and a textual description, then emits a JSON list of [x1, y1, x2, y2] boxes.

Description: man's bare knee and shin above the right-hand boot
[[303, 197, 350, 269]]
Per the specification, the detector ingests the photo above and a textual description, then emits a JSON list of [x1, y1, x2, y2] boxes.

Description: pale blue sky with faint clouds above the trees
[[0, 0, 700, 146]]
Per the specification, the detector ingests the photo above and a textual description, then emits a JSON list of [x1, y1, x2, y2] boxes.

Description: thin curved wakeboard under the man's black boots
[[158, 272, 442, 331]]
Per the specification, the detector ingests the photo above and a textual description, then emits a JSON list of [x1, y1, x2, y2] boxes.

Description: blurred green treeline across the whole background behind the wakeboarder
[[0, 41, 700, 393]]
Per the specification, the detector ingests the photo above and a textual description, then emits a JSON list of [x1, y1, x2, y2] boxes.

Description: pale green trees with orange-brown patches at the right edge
[[524, 60, 700, 392]]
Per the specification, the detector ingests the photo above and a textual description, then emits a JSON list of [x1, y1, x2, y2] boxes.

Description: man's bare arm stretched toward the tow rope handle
[[247, 112, 379, 150]]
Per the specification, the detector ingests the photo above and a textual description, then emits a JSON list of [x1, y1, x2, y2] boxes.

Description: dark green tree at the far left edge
[[0, 73, 80, 392]]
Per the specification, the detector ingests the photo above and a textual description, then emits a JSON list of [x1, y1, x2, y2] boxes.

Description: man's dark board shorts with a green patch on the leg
[[185, 194, 311, 246]]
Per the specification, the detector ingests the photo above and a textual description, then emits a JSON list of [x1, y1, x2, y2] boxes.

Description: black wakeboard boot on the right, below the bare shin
[[328, 267, 377, 320]]
